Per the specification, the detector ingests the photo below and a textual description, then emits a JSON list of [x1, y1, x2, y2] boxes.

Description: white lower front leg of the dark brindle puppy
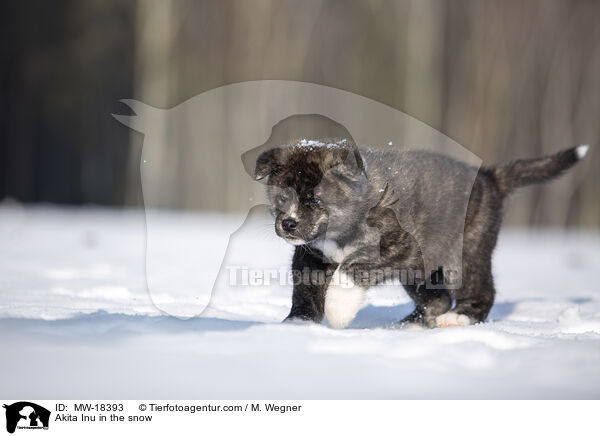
[[325, 268, 365, 329]]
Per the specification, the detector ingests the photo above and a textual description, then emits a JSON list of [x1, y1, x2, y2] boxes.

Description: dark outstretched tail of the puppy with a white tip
[[482, 145, 589, 197]]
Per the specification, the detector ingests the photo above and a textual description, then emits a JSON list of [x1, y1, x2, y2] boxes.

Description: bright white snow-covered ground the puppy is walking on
[[0, 206, 600, 399]]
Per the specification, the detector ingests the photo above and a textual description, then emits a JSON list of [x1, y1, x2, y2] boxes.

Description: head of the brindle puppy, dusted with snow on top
[[254, 139, 366, 245]]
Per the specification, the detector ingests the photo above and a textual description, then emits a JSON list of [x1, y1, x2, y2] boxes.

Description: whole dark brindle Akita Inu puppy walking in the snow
[[254, 126, 586, 327]]
